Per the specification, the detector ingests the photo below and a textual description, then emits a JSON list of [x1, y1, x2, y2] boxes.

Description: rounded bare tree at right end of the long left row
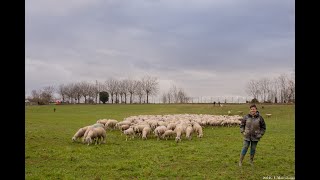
[[141, 76, 159, 103]]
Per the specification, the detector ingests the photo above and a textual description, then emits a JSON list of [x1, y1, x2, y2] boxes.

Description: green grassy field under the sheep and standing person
[[25, 104, 295, 180]]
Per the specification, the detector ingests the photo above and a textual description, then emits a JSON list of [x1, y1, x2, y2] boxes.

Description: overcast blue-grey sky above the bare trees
[[25, 0, 295, 101]]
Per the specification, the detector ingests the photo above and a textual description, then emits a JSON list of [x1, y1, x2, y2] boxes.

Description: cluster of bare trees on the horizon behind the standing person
[[246, 74, 295, 103]]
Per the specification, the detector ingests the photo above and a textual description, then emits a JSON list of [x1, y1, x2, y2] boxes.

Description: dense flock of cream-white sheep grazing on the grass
[[72, 114, 242, 145]]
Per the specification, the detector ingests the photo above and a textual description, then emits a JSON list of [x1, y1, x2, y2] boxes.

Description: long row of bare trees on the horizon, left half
[[28, 76, 159, 104]]
